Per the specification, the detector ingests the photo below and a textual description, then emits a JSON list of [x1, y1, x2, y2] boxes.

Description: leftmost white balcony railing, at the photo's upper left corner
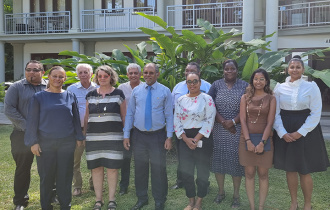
[[5, 11, 71, 34]]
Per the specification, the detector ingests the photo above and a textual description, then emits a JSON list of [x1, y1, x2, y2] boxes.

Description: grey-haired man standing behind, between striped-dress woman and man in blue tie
[[118, 63, 142, 195]]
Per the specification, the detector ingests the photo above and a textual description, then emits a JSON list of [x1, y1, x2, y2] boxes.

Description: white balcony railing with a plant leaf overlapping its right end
[[81, 7, 155, 32]]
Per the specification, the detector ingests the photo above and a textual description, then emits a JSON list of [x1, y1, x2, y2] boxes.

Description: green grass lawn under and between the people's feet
[[0, 125, 330, 210]]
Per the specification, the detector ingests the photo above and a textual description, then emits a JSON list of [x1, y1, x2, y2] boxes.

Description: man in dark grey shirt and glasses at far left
[[4, 60, 47, 210]]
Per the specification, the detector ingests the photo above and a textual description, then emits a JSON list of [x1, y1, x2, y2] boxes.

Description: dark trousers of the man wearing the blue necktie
[[132, 128, 168, 203]]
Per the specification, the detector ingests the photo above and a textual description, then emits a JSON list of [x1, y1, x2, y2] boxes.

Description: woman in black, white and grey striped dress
[[85, 65, 126, 209]]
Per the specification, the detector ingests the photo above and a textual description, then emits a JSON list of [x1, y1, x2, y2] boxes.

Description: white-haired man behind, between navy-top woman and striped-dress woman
[[67, 63, 98, 196]]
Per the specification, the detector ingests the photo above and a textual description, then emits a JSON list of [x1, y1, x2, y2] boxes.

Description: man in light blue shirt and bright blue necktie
[[124, 63, 173, 210]]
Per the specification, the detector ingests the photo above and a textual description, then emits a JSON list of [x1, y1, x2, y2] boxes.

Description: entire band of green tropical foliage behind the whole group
[[42, 13, 330, 89]]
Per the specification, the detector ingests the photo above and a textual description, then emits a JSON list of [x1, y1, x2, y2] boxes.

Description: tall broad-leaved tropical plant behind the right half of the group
[[138, 13, 330, 87]]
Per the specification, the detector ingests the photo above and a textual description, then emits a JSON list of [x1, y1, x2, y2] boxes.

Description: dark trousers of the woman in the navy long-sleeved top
[[37, 136, 76, 210]]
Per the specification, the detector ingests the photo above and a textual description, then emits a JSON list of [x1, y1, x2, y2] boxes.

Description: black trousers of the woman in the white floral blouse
[[179, 129, 212, 198]]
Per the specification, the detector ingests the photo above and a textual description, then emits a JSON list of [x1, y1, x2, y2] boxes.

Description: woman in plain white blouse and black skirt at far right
[[274, 58, 329, 210]]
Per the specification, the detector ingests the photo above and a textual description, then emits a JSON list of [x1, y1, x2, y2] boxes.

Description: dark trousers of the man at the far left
[[10, 130, 34, 206]]
